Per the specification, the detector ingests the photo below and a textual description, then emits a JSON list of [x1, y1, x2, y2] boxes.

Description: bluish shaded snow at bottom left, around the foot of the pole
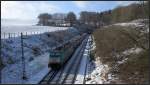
[[2, 53, 50, 84]]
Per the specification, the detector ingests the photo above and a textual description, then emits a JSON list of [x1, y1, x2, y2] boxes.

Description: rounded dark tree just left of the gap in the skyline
[[65, 12, 76, 26]]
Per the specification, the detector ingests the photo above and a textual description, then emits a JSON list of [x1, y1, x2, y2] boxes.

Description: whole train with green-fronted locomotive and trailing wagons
[[48, 34, 87, 69]]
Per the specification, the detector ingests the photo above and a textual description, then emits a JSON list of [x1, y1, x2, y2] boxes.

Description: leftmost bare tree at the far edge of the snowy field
[[38, 13, 52, 25]]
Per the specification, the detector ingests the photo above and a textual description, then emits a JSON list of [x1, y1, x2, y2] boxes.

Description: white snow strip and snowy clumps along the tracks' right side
[[75, 36, 109, 84]]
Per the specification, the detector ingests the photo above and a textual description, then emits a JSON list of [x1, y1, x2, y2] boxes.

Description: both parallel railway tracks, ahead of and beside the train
[[39, 37, 87, 84]]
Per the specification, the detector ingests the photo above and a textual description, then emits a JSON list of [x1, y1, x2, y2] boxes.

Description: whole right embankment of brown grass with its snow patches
[[92, 19, 149, 84]]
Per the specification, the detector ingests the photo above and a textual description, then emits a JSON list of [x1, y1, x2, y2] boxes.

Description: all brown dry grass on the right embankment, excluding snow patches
[[93, 26, 149, 84]]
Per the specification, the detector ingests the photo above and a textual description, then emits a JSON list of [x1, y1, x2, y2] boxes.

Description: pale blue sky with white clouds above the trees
[[1, 1, 139, 20]]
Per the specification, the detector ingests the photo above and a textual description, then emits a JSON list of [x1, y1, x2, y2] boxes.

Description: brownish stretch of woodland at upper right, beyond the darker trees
[[100, 2, 149, 24]]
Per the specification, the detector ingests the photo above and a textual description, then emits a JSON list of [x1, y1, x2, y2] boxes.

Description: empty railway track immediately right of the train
[[56, 36, 87, 84]]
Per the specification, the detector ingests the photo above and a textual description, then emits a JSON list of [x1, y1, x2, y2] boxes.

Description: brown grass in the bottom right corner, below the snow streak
[[118, 50, 149, 84]]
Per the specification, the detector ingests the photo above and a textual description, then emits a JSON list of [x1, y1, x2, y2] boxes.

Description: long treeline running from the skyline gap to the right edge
[[80, 1, 149, 27]]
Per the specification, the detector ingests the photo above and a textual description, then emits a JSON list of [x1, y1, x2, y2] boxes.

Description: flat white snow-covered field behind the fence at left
[[1, 19, 69, 38]]
